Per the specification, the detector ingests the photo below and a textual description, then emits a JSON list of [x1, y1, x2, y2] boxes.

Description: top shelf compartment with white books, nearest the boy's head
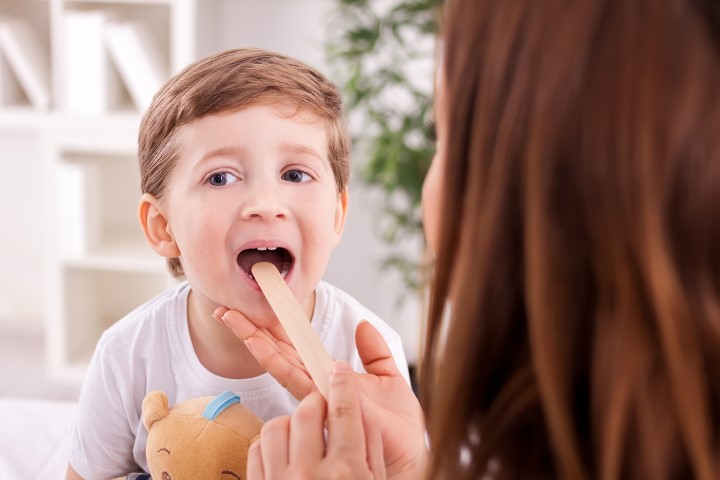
[[58, 1, 172, 116]]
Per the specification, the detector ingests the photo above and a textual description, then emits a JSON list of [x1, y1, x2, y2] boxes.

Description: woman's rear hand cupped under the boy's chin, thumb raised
[[215, 308, 427, 479]]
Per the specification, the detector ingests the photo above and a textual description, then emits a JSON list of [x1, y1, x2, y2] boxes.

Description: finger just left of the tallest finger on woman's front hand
[[290, 391, 325, 466]]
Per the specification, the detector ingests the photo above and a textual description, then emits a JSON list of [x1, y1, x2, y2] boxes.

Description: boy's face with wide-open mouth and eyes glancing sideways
[[151, 105, 347, 326]]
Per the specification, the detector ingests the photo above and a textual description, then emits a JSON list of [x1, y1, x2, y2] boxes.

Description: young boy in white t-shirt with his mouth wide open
[[68, 49, 407, 479]]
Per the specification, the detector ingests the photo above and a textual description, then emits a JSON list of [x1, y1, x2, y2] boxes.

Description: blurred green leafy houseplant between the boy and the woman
[[327, 0, 440, 293]]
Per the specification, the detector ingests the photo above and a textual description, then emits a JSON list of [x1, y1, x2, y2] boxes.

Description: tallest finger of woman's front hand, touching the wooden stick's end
[[327, 362, 365, 459]]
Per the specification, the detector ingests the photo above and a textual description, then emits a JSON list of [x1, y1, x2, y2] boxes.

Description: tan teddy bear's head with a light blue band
[[142, 390, 263, 480]]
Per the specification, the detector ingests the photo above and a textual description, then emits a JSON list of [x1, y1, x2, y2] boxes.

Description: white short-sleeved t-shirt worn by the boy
[[70, 282, 409, 480]]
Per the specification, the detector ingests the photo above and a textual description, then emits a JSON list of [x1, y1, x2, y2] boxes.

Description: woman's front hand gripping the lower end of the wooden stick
[[247, 362, 386, 480]]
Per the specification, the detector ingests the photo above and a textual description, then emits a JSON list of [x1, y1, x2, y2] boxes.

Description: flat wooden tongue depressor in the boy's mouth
[[251, 262, 334, 400]]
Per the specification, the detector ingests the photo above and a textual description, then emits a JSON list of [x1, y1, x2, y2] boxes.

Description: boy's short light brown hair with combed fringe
[[138, 48, 350, 277]]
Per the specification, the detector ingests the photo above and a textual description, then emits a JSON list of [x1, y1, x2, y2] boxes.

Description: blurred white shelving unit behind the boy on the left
[[0, 0, 228, 383]]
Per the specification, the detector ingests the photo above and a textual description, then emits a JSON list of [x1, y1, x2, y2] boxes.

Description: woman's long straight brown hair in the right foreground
[[421, 0, 720, 480]]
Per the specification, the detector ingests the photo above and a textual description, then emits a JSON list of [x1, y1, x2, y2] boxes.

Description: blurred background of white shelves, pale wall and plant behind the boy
[[0, 0, 435, 400]]
